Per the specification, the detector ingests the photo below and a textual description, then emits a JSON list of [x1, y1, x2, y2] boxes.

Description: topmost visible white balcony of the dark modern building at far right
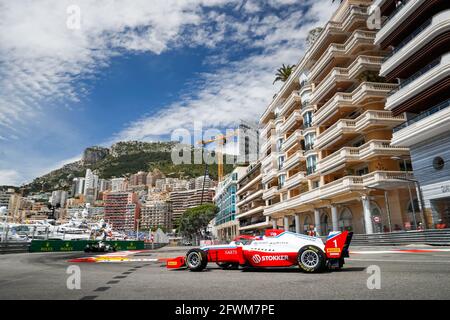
[[375, 0, 429, 45]]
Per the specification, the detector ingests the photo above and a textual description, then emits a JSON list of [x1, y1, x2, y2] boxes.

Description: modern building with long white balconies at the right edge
[[375, 0, 450, 227]]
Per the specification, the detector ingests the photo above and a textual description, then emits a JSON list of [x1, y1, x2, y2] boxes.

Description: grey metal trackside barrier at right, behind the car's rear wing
[[351, 229, 450, 246]]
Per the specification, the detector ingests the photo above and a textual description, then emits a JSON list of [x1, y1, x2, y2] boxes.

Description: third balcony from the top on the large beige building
[[311, 56, 383, 105]]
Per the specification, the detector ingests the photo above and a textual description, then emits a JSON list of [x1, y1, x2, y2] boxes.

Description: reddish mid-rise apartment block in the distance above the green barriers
[[103, 192, 140, 231]]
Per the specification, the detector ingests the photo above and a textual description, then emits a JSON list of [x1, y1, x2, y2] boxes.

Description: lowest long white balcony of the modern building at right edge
[[392, 100, 450, 147]]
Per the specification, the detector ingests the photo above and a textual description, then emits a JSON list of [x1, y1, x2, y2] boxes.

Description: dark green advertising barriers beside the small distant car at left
[[30, 240, 144, 252]]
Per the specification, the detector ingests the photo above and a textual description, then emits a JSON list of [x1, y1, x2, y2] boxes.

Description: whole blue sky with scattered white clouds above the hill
[[0, 0, 337, 185]]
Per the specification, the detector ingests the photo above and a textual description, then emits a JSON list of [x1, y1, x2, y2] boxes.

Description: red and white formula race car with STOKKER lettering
[[167, 229, 353, 272]]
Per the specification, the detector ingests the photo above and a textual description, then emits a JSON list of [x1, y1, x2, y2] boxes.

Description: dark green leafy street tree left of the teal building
[[178, 203, 219, 238]]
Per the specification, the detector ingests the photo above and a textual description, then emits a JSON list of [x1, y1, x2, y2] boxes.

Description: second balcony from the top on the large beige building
[[309, 30, 376, 81]]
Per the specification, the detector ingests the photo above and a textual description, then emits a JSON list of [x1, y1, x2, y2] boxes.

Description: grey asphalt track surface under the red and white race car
[[0, 247, 450, 300]]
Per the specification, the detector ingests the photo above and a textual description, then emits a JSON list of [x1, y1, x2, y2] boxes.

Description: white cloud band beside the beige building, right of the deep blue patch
[[116, 0, 335, 140]]
